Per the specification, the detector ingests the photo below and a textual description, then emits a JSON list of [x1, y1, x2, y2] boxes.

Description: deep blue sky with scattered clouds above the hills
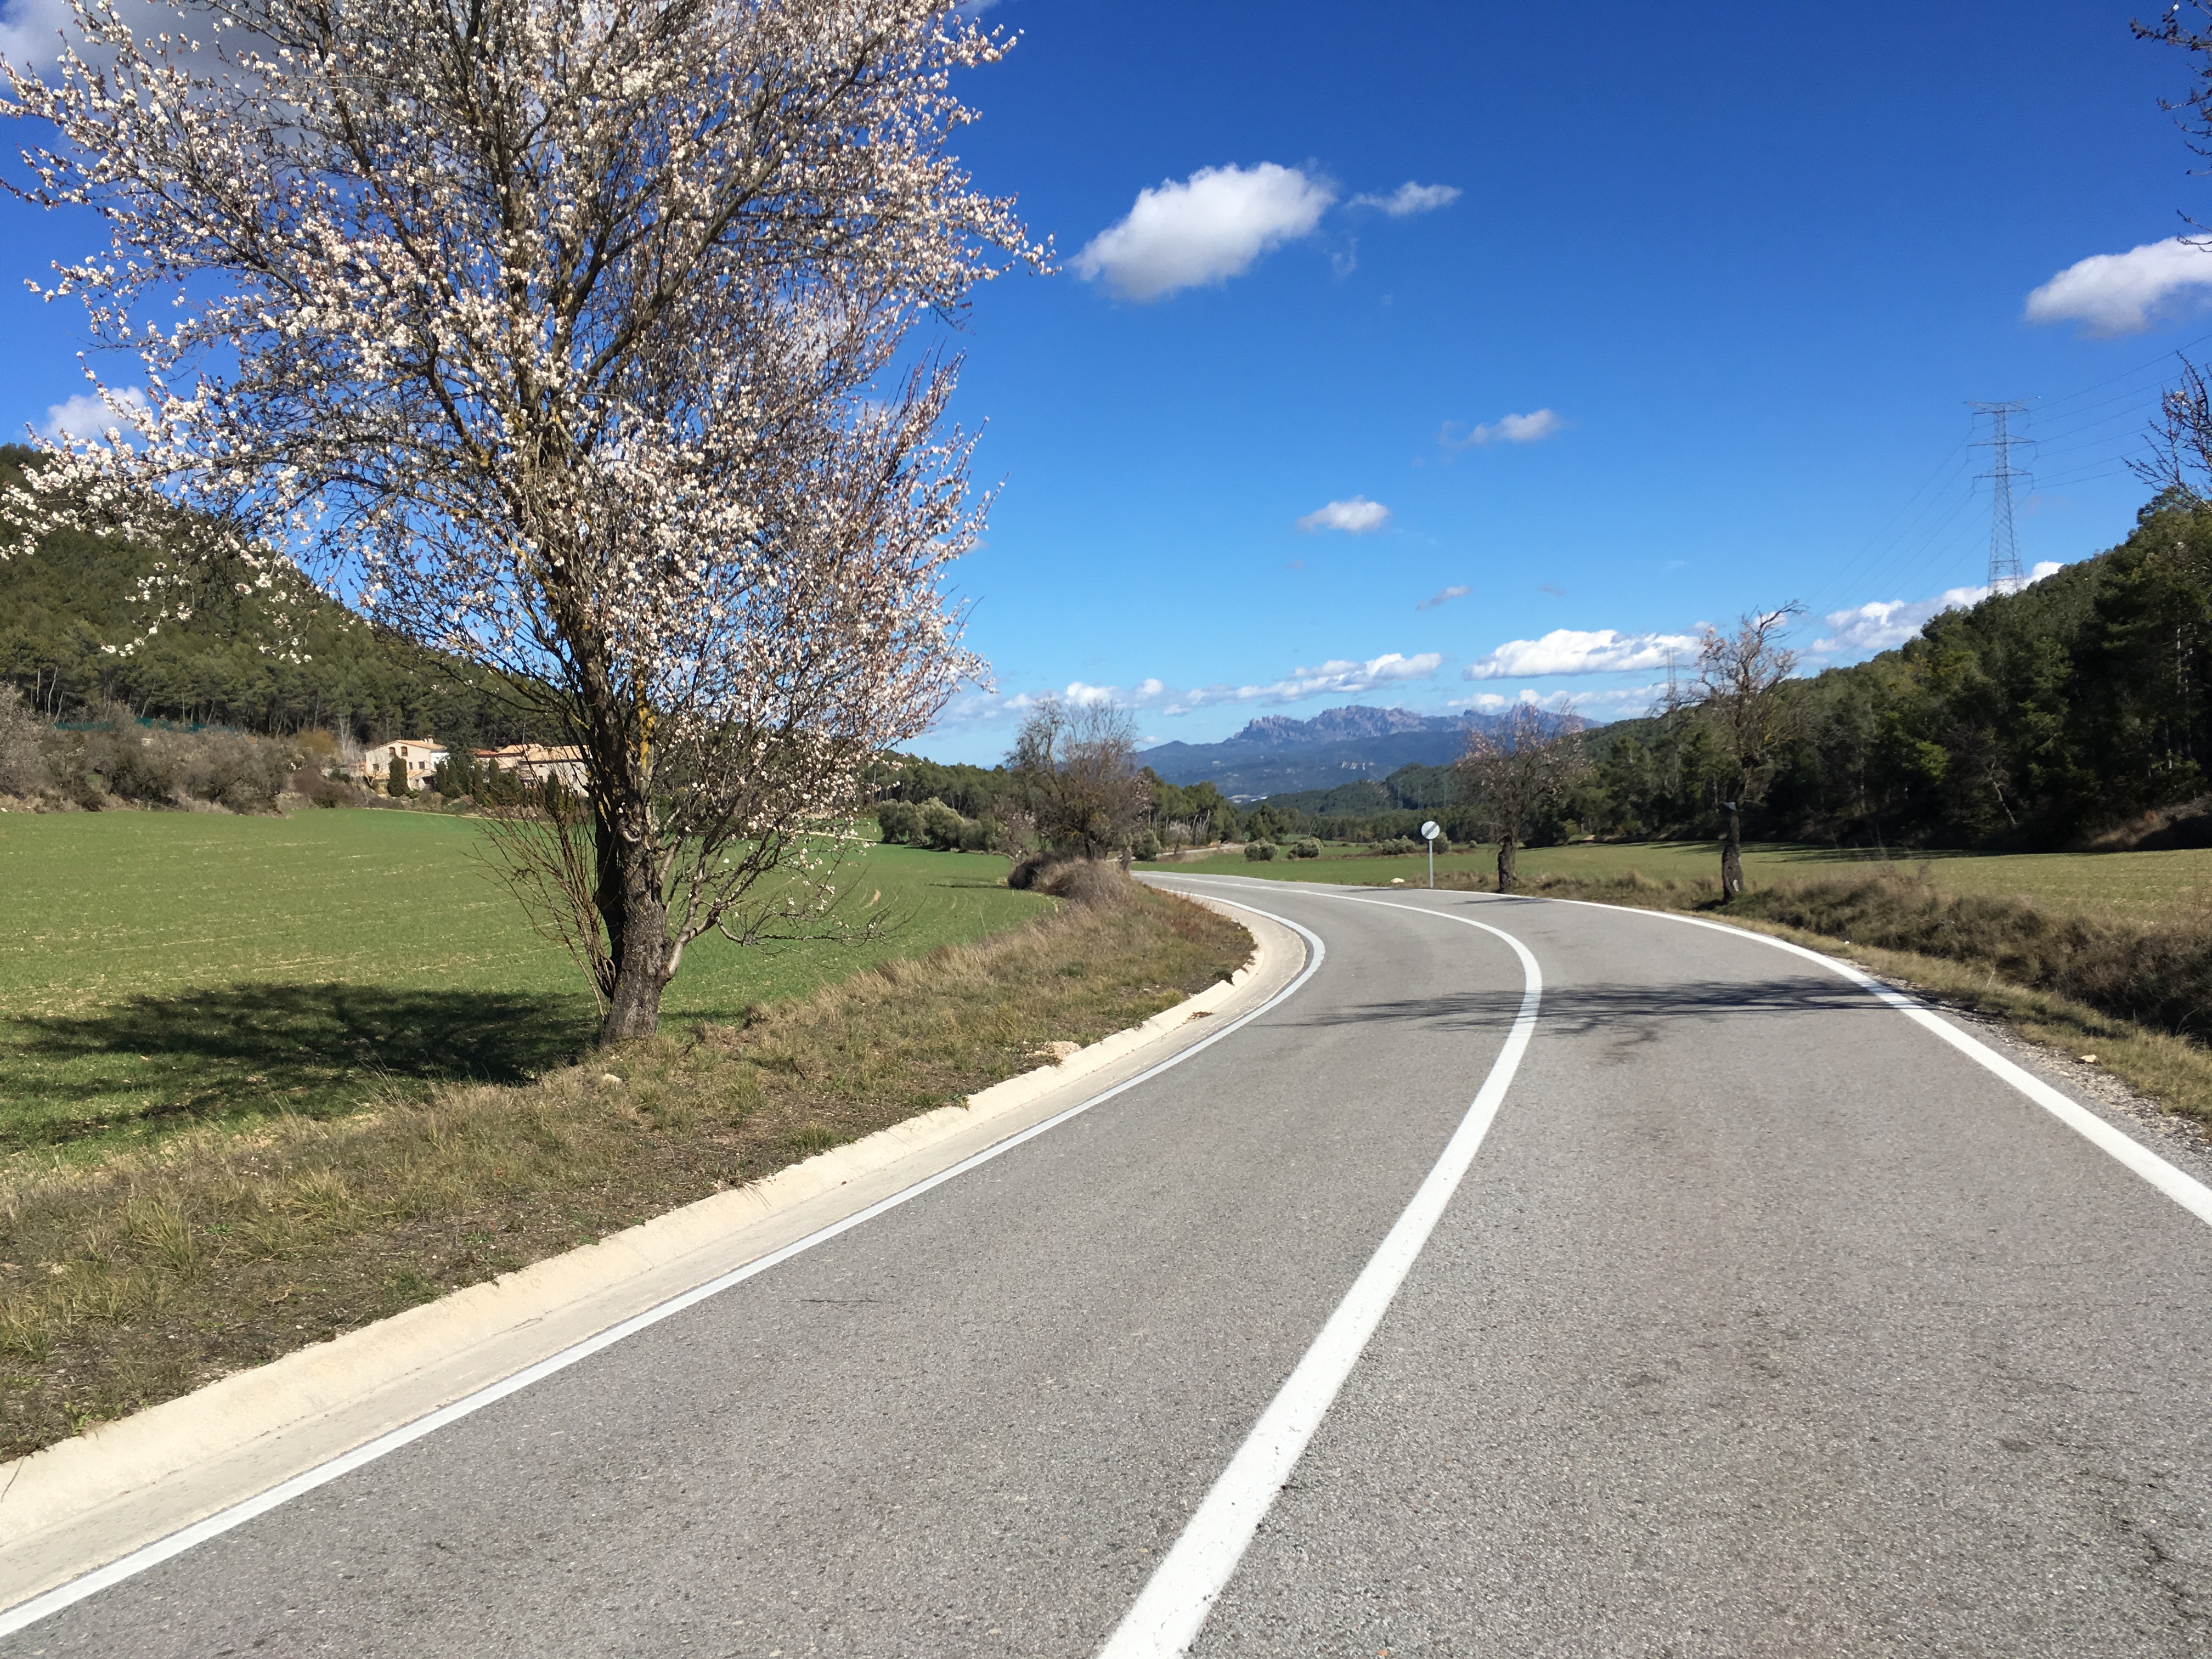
[[0, 0, 2212, 761]]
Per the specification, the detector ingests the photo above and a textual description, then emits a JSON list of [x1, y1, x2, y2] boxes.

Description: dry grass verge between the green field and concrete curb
[[0, 883, 1250, 1455]]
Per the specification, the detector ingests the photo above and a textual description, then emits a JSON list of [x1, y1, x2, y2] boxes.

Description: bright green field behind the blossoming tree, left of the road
[[0, 812, 1053, 1150]]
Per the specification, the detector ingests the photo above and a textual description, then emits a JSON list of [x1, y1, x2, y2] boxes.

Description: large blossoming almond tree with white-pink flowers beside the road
[[0, 0, 1046, 1040]]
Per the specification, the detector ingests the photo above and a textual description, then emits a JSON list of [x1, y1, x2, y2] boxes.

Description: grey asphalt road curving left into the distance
[[13, 878, 2212, 1659]]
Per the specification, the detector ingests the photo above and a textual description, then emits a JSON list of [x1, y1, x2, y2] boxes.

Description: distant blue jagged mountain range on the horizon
[[1137, 703, 1498, 801]]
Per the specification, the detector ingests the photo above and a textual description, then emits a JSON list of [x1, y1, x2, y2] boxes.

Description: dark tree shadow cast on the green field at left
[[0, 984, 591, 1148]]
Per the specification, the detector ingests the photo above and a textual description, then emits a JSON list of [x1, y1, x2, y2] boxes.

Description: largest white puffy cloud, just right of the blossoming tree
[[1070, 161, 1336, 301]]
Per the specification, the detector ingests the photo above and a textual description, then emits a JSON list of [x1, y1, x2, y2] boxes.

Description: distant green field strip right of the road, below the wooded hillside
[[1146, 840, 2212, 924]]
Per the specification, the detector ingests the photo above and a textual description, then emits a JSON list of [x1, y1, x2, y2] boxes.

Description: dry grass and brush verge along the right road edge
[[1438, 870, 2212, 1121]]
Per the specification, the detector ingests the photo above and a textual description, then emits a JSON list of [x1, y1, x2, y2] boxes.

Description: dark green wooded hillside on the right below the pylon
[[1583, 495, 2212, 849]]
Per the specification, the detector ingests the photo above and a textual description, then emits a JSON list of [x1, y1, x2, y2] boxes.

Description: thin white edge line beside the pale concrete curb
[[0, 898, 1318, 1637]]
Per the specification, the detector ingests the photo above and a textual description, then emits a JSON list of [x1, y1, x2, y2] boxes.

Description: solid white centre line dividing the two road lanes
[[1097, 898, 1544, 1659]]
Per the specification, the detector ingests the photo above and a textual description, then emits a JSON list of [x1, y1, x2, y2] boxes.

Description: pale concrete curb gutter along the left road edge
[[0, 896, 1305, 1608]]
